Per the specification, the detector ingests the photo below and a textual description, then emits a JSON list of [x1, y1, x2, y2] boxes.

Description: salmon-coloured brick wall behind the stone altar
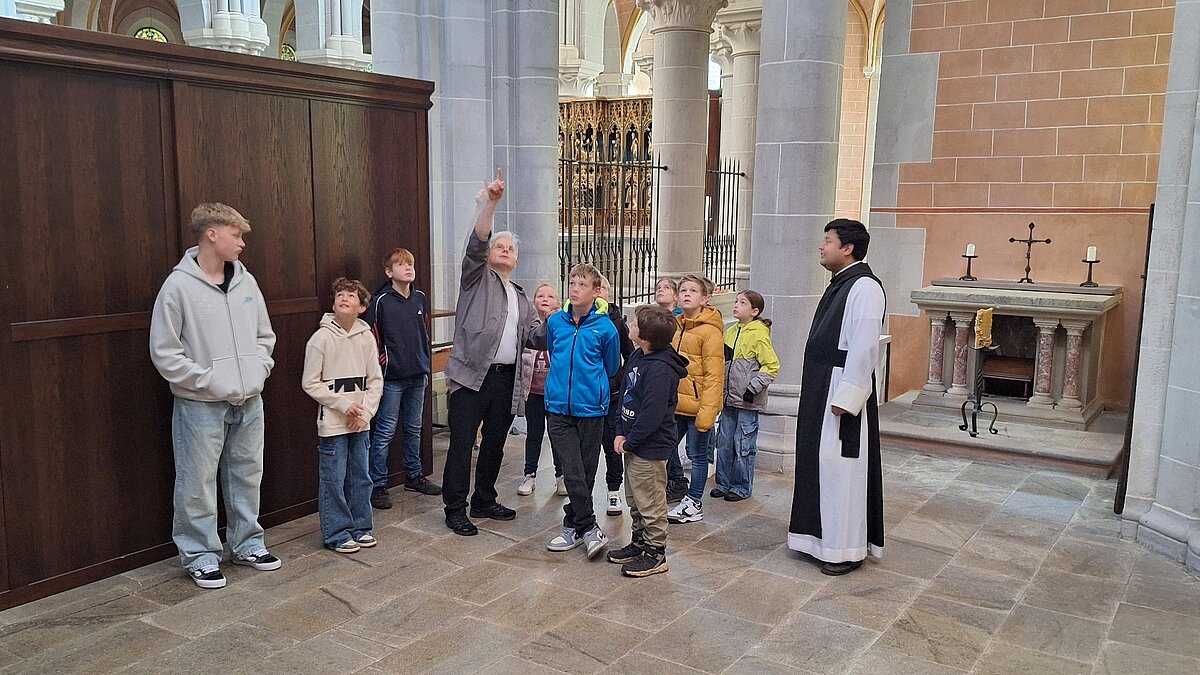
[[893, 0, 1174, 410]]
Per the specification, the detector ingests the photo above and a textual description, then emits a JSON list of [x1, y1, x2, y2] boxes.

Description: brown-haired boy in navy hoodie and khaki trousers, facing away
[[608, 305, 688, 577]]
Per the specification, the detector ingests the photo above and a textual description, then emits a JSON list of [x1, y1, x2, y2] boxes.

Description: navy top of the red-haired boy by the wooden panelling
[[362, 281, 430, 381]]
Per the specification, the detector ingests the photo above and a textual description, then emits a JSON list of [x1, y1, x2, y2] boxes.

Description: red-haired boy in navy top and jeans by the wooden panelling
[[362, 249, 442, 509]]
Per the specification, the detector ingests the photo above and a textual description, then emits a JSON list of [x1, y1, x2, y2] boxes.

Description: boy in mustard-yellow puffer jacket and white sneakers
[[667, 274, 725, 522]]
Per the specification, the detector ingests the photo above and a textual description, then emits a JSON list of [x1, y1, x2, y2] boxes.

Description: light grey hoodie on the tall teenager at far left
[[150, 246, 275, 406]]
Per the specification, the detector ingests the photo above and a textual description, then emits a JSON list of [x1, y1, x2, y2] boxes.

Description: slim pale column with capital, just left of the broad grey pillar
[[716, 0, 762, 291]]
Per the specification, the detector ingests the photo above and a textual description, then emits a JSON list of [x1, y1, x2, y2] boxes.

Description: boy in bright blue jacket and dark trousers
[[545, 264, 620, 557]]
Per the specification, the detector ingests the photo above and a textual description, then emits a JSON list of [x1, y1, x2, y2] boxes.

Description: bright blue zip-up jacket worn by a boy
[[545, 298, 620, 417]]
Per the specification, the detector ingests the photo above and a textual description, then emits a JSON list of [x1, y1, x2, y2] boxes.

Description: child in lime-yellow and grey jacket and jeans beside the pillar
[[708, 291, 779, 502]]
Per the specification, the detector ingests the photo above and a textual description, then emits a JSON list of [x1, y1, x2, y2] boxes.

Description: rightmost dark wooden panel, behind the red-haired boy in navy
[[312, 101, 433, 477]]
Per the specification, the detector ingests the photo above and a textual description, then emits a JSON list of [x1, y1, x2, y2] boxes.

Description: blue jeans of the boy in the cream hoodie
[[317, 431, 374, 549]]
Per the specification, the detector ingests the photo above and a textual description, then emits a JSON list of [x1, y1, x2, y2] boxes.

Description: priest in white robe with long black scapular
[[787, 219, 884, 575]]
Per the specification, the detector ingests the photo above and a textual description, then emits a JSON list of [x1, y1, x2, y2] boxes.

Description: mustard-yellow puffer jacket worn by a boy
[[672, 307, 725, 432]]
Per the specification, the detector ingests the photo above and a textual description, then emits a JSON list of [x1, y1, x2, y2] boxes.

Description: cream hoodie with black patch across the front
[[301, 312, 383, 437]]
